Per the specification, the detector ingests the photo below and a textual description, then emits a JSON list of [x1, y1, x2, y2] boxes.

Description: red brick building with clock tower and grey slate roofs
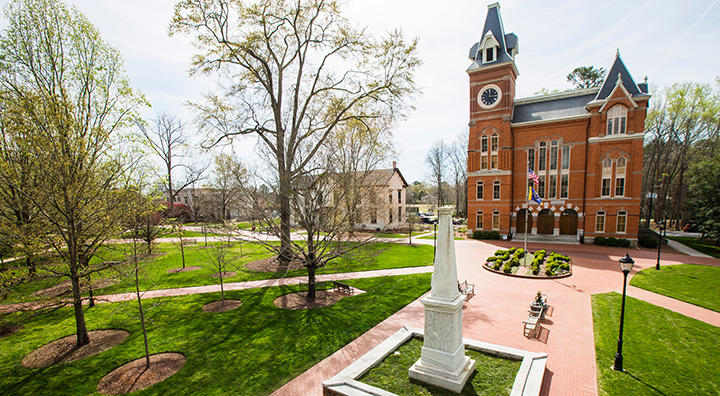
[[467, 3, 650, 243]]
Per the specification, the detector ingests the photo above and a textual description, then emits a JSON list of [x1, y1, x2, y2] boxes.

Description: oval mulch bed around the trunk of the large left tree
[[22, 330, 130, 368]]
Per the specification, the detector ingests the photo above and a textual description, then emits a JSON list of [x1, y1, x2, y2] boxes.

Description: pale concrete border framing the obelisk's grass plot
[[322, 326, 547, 396]]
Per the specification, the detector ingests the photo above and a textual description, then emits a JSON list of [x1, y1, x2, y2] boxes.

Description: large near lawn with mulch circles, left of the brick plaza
[[0, 274, 430, 396]]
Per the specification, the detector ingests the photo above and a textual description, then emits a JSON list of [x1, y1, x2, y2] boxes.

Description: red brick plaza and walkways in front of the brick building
[[272, 241, 720, 396]]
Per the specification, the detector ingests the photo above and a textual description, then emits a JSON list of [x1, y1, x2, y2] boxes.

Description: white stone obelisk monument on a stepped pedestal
[[408, 207, 475, 393]]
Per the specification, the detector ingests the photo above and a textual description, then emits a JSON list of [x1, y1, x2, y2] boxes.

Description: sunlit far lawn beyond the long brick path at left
[[1, 242, 433, 304]]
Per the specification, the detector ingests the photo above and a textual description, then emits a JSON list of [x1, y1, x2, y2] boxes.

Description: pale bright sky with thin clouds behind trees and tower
[[0, 0, 720, 183]]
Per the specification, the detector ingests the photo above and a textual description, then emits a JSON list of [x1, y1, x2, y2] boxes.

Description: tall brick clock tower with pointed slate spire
[[467, 3, 519, 234]]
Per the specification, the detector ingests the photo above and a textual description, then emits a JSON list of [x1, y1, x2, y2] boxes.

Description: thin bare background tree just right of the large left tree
[[137, 113, 208, 207]]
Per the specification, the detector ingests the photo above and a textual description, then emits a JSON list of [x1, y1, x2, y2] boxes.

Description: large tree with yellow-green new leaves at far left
[[0, 0, 145, 346]]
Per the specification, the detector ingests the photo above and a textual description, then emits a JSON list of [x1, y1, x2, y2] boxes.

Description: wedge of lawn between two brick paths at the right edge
[[630, 264, 720, 312]]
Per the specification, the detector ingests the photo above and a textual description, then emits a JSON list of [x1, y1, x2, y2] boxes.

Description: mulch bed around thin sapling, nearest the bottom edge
[[97, 353, 185, 395]]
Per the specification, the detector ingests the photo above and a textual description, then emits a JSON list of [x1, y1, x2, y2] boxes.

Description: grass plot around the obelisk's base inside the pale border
[[359, 338, 521, 396]]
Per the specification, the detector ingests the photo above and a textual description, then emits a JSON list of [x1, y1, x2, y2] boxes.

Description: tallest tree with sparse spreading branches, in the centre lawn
[[171, 0, 420, 261]]
